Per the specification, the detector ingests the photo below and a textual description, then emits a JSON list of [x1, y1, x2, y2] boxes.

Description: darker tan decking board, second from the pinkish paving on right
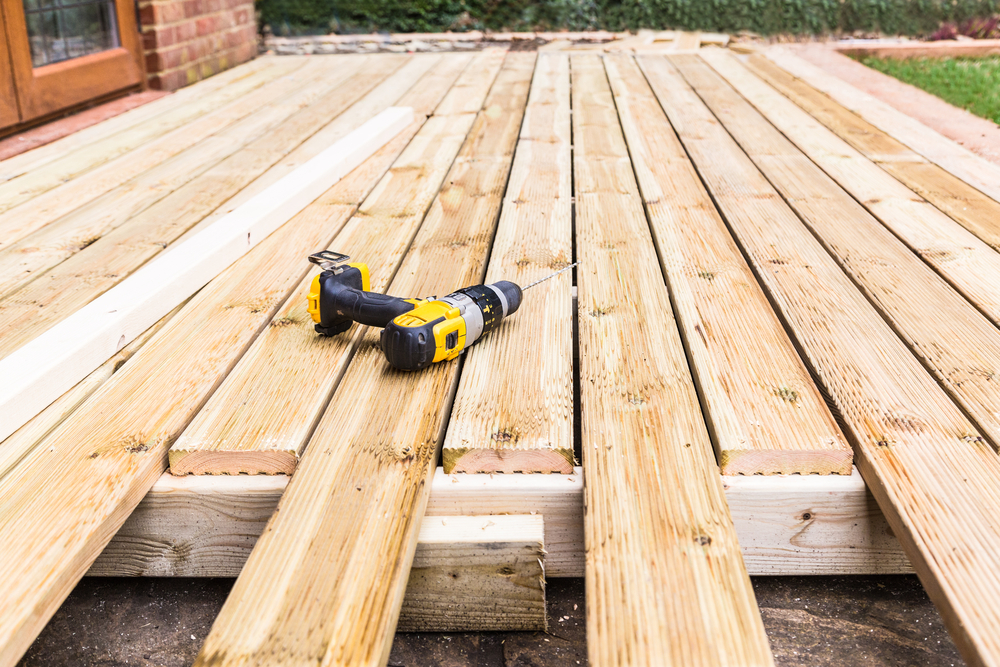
[[746, 55, 1000, 250]]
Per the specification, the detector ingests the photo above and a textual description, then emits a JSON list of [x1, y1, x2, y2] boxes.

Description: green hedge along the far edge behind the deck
[[257, 0, 1000, 35]]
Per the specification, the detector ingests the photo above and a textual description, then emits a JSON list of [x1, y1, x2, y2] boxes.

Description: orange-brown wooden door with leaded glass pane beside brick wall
[[0, 0, 144, 122]]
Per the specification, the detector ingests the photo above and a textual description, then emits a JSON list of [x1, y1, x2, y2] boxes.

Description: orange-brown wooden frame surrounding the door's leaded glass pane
[[0, 0, 146, 122]]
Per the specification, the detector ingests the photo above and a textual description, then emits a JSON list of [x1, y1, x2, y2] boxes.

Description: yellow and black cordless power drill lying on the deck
[[309, 250, 576, 371]]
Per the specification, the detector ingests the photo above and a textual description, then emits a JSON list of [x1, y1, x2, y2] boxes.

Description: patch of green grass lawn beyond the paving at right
[[860, 56, 1000, 124]]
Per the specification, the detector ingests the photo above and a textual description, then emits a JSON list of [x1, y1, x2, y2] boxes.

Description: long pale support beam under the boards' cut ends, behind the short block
[[88, 467, 913, 580]]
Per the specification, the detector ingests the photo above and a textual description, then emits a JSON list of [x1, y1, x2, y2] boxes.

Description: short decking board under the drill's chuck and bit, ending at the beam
[[442, 55, 574, 473]]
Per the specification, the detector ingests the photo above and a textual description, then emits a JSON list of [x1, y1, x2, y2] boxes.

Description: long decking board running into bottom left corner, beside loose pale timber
[[0, 92, 426, 665]]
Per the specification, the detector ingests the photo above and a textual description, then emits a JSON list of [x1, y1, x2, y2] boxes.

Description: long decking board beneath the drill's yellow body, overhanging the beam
[[188, 53, 535, 665]]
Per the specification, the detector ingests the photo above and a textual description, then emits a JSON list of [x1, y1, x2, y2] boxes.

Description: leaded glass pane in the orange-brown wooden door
[[23, 0, 121, 67]]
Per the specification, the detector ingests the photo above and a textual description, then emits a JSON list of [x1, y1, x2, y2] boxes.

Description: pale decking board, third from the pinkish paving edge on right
[[696, 53, 1000, 332]]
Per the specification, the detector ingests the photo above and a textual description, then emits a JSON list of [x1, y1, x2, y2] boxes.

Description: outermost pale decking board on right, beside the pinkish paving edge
[[765, 47, 1000, 206]]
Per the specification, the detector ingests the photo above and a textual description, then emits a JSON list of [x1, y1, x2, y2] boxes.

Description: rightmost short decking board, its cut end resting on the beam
[[604, 57, 852, 475]]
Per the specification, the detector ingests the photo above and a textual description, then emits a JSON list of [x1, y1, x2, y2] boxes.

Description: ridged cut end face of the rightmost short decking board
[[719, 449, 854, 475]]
